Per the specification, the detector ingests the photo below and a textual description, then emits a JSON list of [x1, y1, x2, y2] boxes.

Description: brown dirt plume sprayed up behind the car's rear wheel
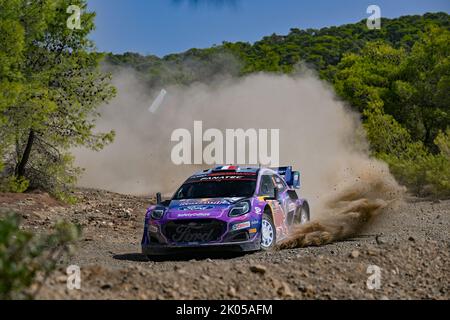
[[277, 159, 404, 249]]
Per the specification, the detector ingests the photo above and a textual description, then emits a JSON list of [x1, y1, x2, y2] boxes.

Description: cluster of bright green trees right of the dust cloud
[[334, 28, 450, 197]]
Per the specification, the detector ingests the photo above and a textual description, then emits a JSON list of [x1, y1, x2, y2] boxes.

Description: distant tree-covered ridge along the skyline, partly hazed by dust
[[108, 12, 450, 86]]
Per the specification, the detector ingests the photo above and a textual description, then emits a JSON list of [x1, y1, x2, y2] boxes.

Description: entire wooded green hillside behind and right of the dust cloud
[[107, 13, 450, 197]]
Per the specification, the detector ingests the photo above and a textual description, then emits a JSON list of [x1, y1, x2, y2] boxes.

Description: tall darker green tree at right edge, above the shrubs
[[398, 27, 450, 151]]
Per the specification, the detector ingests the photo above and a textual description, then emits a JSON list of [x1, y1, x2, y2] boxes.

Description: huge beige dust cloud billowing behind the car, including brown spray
[[75, 69, 399, 238]]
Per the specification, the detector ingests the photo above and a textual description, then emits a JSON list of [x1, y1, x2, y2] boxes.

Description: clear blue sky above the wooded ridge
[[88, 0, 450, 56]]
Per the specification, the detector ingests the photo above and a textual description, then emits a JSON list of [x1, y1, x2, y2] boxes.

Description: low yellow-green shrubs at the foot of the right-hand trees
[[364, 108, 450, 197]]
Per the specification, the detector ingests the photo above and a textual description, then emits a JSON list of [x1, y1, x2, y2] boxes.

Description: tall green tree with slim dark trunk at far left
[[0, 0, 115, 199]]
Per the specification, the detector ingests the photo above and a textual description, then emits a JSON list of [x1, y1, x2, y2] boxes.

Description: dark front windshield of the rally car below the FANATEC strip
[[173, 175, 256, 200]]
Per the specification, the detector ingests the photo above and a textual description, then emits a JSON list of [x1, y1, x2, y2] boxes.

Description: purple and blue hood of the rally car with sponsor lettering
[[166, 197, 244, 219]]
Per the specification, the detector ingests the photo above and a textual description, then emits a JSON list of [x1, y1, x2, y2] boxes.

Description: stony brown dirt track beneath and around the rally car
[[0, 190, 450, 299]]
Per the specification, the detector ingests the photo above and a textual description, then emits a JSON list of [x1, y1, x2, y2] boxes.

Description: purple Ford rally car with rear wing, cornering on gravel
[[142, 166, 309, 255]]
